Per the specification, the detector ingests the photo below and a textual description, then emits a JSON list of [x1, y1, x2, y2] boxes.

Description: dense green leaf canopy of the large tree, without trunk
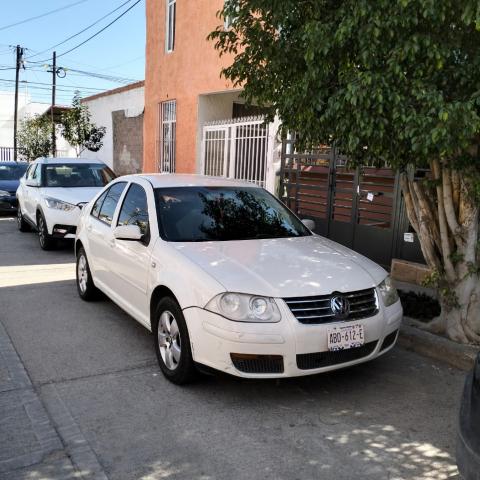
[[210, 0, 480, 180]]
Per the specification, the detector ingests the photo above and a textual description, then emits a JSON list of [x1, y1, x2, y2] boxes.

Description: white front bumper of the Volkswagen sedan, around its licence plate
[[183, 299, 403, 378]]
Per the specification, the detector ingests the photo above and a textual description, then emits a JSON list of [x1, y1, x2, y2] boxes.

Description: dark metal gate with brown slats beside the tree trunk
[[280, 140, 418, 267]]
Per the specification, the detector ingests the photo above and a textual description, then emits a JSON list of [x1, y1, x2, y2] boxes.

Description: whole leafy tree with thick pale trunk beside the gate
[[210, 0, 480, 343]]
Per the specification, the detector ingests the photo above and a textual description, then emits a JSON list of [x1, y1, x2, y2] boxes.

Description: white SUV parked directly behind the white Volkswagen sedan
[[17, 158, 115, 250]]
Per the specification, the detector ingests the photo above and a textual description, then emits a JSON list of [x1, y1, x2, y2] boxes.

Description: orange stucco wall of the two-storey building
[[143, 0, 235, 173]]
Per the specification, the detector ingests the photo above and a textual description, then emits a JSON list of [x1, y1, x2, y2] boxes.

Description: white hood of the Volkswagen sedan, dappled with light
[[175, 235, 387, 297]]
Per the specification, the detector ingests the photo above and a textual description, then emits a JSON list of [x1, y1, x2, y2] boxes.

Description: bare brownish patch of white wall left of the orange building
[[112, 110, 143, 175]]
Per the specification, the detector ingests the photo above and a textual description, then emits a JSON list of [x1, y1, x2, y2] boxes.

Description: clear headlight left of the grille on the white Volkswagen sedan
[[205, 292, 281, 323]]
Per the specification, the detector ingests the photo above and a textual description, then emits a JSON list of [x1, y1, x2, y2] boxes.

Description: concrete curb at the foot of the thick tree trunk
[[398, 317, 479, 371]]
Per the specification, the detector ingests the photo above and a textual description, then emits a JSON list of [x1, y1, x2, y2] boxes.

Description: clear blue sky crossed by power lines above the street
[[0, 0, 145, 104]]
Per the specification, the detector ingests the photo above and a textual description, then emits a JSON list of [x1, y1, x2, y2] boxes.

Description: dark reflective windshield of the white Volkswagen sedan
[[155, 187, 311, 242]]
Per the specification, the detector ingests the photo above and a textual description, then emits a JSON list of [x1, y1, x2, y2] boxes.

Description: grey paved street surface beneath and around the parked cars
[[0, 217, 464, 480]]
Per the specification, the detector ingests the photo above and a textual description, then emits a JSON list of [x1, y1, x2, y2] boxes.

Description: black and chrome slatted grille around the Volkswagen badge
[[283, 288, 378, 324]]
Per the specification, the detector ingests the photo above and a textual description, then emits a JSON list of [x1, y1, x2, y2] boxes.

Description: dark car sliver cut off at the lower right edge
[[457, 353, 480, 480]]
